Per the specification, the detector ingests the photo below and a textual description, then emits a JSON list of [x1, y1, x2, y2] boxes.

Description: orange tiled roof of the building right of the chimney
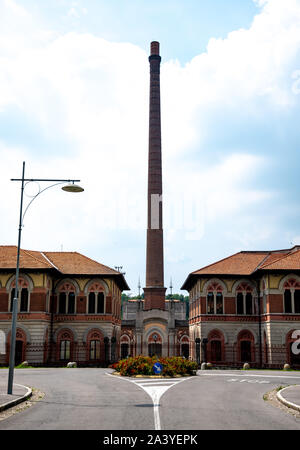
[[181, 246, 300, 289]]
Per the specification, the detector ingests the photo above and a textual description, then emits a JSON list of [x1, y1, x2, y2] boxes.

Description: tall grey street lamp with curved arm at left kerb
[[7, 161, 84, 394]]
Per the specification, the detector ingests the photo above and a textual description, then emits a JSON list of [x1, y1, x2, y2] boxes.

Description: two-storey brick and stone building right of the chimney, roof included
[[182, 246, 300, 368]]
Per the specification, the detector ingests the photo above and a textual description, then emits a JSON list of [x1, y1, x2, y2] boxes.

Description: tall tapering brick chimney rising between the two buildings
[[144, 41, 166, 309]]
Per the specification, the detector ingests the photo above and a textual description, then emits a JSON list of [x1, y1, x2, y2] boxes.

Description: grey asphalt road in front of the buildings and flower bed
[[0, 368, 300, 430]]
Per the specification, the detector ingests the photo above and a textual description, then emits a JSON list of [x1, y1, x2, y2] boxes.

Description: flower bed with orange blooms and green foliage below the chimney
[[110, 356, 197, 377]]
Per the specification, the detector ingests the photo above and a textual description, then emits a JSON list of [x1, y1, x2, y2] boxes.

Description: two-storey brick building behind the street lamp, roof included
[[0, 246, 129, 366]]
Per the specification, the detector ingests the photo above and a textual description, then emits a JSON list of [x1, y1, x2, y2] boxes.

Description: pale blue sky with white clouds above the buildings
[[0, 0, 300, 295]]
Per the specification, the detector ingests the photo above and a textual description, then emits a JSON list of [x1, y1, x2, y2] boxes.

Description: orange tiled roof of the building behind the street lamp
[[0, 245, 129, 290]]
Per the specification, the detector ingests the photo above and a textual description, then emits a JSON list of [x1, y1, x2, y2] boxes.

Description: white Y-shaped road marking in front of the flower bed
[[106, 373, 194, 430]]
